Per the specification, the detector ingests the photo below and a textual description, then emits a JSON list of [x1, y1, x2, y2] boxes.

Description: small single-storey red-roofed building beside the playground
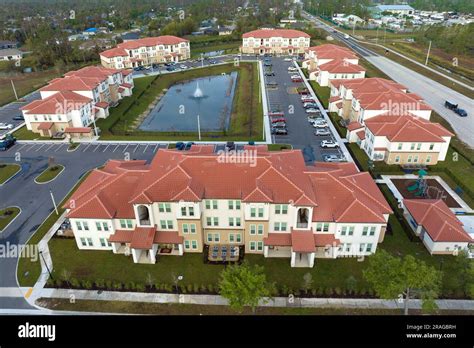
[[402, 199, 474, 256]]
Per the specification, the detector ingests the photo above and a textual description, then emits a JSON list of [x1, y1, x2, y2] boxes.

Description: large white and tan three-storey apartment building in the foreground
[[66, 146, 392, 267]]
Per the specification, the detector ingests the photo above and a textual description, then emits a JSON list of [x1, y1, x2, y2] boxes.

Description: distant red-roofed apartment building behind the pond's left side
[[100, 35, 191, 69]]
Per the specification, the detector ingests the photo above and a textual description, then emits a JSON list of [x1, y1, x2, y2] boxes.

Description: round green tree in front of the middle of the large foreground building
[[219, 262, 274, 313]]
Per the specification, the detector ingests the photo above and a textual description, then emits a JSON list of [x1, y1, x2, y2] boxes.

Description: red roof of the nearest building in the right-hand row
[[365, 115, 454, 142]]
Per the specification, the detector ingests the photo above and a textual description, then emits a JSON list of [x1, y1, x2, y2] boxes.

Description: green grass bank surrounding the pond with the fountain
[[97, 63, 263, 141]]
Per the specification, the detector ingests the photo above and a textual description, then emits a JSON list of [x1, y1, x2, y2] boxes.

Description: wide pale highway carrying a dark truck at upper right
[[305, 14, 474, 148]]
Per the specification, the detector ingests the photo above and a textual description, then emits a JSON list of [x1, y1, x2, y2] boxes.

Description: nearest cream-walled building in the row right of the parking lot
[[346, 115, 454, 165]]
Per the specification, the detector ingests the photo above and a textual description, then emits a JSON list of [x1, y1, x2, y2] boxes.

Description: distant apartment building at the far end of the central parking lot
[[240, 28, 311, 56]]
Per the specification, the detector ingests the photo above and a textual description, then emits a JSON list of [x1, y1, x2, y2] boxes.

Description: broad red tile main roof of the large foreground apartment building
[[69, 145, 391, 222]]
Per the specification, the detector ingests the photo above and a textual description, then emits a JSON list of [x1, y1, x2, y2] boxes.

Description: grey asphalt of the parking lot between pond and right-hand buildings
[[262, 57, 343, 162]]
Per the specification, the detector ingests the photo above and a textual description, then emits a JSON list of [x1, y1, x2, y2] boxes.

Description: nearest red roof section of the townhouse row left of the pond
[[21, 91, 92, 115]]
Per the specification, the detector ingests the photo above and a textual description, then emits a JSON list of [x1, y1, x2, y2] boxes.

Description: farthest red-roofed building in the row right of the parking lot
[[302, 44, 365, 86]]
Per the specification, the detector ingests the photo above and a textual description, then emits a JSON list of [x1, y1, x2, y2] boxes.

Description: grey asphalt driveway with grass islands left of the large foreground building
[[0, 143, 165, 308]]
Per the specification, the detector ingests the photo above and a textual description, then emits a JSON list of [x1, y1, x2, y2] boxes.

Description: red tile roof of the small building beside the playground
[[403, 199, 474, 243]]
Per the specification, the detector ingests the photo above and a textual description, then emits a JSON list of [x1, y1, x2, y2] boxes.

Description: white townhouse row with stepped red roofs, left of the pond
[[21, 66, 134, 138]]
